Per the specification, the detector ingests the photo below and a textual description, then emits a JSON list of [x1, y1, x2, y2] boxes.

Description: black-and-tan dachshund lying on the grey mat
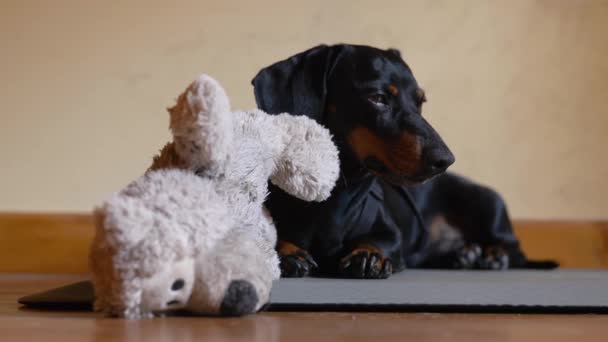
[[252, 44, 557, 278]]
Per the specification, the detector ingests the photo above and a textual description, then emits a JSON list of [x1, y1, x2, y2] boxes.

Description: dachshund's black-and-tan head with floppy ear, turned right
[[252, 44, 454, 185]]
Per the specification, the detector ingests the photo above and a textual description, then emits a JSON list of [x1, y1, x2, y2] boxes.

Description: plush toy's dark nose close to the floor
[[220, 280, 259, 316]]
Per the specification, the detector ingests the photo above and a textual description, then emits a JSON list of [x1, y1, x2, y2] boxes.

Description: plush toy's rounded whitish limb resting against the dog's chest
[[270, 114, 340, 201]]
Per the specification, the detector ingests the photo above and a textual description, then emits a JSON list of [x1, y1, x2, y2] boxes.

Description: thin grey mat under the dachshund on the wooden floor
[[19, 270, 608, 313]]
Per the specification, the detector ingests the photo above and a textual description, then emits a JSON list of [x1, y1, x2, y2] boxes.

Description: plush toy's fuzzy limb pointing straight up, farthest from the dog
[[169, 75, 233, 174]]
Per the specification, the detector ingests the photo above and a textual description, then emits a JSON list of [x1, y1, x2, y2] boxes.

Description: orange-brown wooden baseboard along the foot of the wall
[[0, 213, 608, 273]]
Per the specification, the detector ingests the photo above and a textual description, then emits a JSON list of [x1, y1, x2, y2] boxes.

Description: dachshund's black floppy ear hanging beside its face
[[251, 45, 339, 122]]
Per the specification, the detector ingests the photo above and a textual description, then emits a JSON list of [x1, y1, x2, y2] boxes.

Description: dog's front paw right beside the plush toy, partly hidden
[[277, 241, 319, 278]]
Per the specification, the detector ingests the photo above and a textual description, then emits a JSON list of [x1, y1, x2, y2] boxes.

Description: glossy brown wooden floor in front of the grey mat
[[0, 273, 608, 342]]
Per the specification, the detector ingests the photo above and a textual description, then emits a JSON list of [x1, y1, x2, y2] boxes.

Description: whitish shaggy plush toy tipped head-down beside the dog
[[90, 75, 339, 318]]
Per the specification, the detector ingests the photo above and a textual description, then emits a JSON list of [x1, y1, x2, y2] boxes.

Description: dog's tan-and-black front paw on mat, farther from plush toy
[[338, 244, 393, 279]]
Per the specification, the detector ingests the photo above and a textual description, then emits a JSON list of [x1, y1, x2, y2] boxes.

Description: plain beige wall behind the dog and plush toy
[[0, 0, 608, 219]]
